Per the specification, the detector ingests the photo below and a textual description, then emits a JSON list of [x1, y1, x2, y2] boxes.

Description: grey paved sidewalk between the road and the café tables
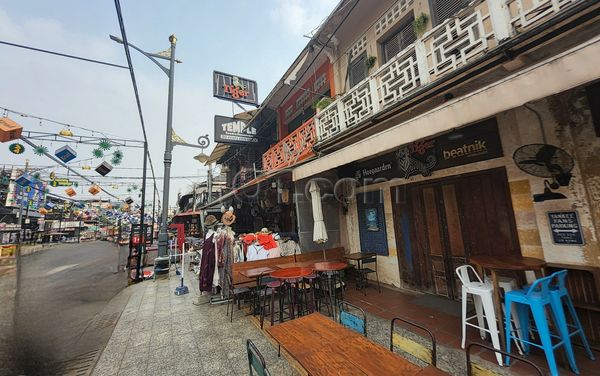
[[93, 272, 296, 376]]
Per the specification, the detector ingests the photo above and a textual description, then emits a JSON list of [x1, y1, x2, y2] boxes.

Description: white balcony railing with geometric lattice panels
[[315, 0, 585, 142]]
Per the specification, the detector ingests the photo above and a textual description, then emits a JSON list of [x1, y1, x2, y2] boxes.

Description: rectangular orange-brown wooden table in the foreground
[[266, 313, 445, 376]]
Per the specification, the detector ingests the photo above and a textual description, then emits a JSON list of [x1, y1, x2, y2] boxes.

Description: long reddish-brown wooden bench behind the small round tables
[[232, 247, 345, 286]]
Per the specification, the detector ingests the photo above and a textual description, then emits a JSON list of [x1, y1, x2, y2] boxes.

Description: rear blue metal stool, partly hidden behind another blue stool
[[550, 269, 596, 360]]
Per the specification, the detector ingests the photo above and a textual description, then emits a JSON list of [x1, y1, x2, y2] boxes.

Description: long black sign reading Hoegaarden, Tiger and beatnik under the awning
[[338, 119, 503, 184]]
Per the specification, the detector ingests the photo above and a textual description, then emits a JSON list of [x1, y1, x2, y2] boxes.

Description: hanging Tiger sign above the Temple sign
[[213, 71, 258, 106]]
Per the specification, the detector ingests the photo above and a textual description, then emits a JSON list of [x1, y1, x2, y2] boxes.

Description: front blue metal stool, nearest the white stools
[[505, 276, 579, 376]]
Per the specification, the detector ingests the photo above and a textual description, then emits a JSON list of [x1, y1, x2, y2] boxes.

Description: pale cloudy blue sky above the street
[[0, 0, 337, 210]]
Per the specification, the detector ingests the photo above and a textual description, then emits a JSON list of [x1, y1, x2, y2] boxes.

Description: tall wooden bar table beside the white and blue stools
[[469, 255, 546, 348]]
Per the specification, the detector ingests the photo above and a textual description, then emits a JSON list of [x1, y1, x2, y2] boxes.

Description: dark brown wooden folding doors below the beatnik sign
[[391, 168, 520, 299]]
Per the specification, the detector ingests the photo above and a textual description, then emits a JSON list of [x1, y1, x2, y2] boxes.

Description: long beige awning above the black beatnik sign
[[293, 37, 600, 181]]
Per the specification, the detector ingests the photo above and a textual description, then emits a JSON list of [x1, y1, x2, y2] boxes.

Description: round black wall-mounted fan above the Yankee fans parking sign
[[513, 144, 574, 186]]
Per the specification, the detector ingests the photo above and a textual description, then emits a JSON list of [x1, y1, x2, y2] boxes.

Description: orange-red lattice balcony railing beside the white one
[[262, 118, 317, 171]]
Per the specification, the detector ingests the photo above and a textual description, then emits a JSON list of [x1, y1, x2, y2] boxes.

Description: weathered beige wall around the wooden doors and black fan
[[345, 89, 600, 286]]
